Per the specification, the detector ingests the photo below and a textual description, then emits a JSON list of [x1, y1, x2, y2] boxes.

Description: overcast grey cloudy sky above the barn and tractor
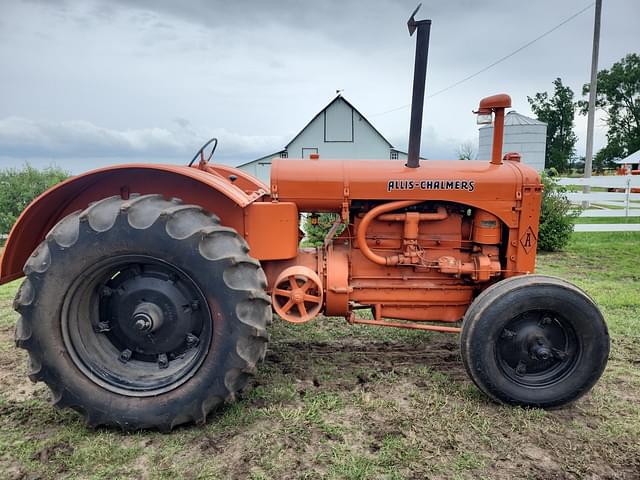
[[0, 0, 640, 173]]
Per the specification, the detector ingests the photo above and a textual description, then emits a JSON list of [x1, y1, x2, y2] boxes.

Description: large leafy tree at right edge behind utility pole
[[579, 53, 640, 167]]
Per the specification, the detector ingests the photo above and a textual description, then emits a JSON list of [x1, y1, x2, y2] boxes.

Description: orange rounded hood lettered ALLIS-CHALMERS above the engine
[[271, 159, 540, 225]]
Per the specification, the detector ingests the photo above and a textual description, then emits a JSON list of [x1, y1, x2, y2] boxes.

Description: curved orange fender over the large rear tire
[[0, 164, 268, 284]]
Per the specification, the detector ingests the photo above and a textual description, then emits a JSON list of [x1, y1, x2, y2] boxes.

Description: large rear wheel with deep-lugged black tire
[[14, 195, 271, 431]]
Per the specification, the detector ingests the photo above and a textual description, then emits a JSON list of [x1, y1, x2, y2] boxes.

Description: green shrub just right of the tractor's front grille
[[538, 172, 580, 252]]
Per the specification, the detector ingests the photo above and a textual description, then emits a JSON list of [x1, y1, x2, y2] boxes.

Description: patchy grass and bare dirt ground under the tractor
[[0, 233, 640, 479]]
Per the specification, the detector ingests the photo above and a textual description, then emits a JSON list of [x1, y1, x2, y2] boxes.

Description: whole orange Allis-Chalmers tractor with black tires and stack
[[0, 6, 609, 430]]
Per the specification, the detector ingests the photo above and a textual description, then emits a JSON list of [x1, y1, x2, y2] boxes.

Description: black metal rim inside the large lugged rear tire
[[61, 255, 213, 397]]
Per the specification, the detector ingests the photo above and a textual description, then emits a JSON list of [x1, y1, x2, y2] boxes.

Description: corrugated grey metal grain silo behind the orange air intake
[[478, 111, 547, 171]]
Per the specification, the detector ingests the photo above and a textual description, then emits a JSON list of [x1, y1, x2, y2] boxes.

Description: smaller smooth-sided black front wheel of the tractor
[[460, 275, 609, 408]]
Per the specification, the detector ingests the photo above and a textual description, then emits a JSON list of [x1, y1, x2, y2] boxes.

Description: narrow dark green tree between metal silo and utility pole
[[527, 78, 578, 172]]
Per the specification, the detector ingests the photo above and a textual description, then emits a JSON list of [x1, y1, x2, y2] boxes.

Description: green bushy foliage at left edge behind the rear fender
[[0, 164, 69, 235]]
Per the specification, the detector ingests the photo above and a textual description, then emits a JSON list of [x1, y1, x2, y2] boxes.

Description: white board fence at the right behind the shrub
[[558, 175, 640, 232]]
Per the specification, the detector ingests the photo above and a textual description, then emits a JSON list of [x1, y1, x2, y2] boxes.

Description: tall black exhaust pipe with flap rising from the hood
[[406, 3, 431, 168]]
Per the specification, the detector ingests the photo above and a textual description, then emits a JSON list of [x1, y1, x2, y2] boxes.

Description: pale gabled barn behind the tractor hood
[[238, 95, 407, 185]]
